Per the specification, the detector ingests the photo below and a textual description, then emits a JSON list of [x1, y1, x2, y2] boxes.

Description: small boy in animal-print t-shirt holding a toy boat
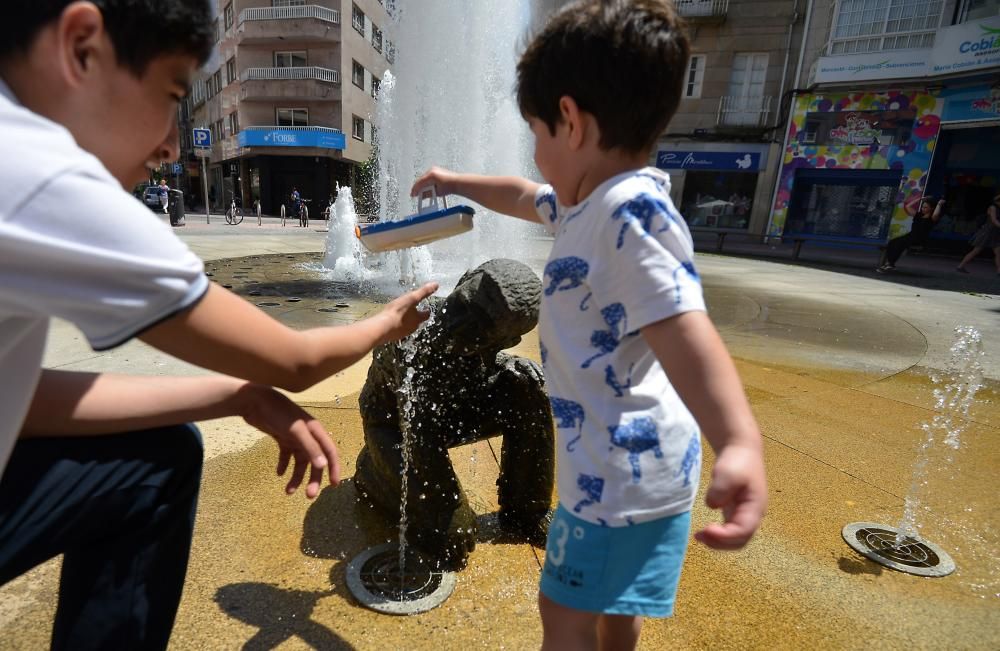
[[413, 0, 767, 649]]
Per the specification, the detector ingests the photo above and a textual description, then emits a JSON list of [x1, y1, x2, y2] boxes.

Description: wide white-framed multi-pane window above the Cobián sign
[[830, 0, 944, 54]]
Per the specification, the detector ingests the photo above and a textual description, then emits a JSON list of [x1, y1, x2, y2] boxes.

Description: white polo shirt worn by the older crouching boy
[[0, 80, 208, 473]]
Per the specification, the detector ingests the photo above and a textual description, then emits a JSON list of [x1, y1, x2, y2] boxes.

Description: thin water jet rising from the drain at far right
[[896, 326, 983, 546]]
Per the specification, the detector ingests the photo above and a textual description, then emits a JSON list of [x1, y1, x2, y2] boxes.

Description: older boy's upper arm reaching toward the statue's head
[[139, 283, 437, 391]]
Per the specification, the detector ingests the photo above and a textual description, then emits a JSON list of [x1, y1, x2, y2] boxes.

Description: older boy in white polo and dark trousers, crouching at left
[[0, 0, 435, 649]]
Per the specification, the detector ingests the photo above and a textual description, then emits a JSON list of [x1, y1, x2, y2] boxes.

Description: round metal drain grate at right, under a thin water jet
[[841, 522, 955, 577]]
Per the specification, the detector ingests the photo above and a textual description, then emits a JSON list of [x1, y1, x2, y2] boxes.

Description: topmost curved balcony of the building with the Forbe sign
[[236, 5, 340, 45]]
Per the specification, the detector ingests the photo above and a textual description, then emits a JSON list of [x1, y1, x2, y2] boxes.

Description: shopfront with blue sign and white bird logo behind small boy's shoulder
[[656, 143, 770, 230]]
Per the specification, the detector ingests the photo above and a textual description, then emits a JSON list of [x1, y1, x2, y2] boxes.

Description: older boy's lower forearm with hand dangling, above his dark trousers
[[21, 370, 340, 499]]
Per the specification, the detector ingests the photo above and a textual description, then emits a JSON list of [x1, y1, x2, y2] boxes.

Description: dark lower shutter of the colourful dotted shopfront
[[784, 170, 901, 240]]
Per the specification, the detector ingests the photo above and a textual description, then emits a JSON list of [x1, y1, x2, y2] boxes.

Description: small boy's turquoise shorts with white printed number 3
[[539, 504, 691, 617]]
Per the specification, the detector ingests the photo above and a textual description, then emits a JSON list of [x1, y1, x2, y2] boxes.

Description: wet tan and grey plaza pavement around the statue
[[0, 218, 1000, 650]]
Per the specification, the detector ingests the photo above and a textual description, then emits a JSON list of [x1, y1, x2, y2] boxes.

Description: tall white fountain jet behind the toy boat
[[330, 0, 537, 288]]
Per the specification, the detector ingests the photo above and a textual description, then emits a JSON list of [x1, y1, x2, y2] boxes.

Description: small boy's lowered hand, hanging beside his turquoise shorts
[[694, 445, 767, 550]]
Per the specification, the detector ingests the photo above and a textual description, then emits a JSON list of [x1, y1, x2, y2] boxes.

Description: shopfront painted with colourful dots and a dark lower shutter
[[768, 90, 940, 240]]
